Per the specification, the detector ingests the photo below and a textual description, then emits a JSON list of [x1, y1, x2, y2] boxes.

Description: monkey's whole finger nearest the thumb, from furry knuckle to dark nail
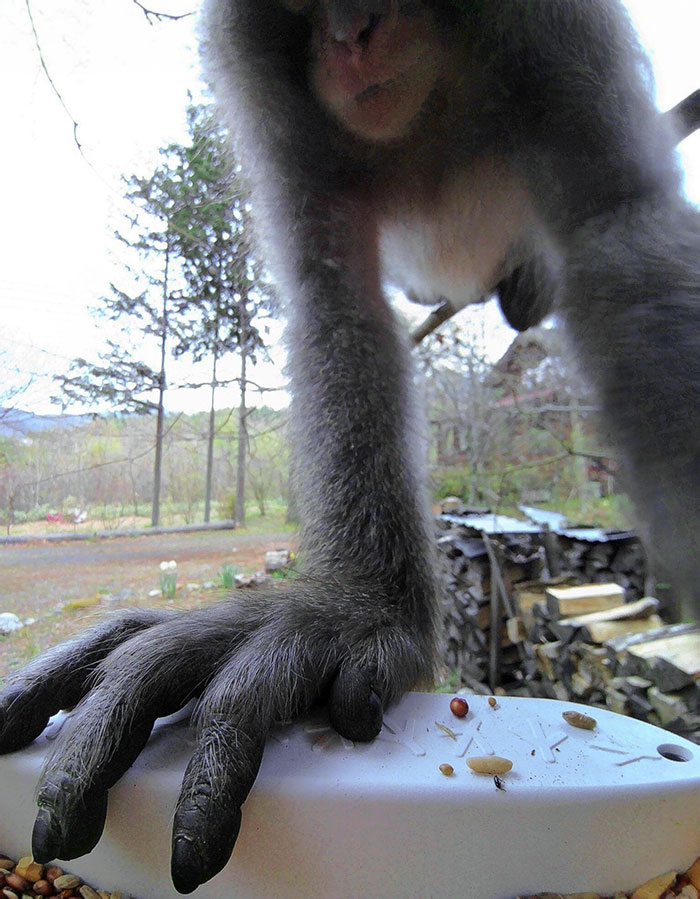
[[172, 624, 337, 893]]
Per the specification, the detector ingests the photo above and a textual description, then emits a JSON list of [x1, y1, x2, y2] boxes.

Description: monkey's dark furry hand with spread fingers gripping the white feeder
[[0, 581, 432, 893]]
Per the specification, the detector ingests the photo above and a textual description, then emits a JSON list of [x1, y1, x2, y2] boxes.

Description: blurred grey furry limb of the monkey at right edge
[[561, 198, 700, 614]]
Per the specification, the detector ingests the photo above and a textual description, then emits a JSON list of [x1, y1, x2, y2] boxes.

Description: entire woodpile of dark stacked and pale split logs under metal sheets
[[438, 520, 700, 742]]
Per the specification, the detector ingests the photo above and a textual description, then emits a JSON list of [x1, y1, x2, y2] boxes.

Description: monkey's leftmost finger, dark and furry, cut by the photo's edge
[[0, 609, 172, 753]]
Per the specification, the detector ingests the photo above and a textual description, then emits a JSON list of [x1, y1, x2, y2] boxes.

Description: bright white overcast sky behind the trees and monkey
[[0, 0, 700, 412]]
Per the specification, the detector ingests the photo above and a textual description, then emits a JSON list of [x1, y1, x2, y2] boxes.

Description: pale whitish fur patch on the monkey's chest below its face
[[379, 161, 534, 309]]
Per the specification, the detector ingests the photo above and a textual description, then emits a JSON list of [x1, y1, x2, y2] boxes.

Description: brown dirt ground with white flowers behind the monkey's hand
[[0, 531, 296, 678]]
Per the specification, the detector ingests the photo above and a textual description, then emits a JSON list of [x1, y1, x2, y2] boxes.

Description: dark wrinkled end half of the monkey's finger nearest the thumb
[[171, 720, 265, 893]]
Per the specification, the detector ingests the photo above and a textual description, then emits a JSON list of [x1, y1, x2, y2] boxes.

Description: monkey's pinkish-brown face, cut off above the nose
[[285, 0, 447, 142]]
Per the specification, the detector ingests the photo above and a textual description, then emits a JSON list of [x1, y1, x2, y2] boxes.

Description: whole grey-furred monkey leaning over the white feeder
[[0, 0, 700, 893]]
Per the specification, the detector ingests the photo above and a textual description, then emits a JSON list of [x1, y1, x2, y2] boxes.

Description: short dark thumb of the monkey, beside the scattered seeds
[[328, 667, 383, 743]]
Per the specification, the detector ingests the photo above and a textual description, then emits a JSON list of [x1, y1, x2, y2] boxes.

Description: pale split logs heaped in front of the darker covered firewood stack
[[524, 584, 700, 742]]
